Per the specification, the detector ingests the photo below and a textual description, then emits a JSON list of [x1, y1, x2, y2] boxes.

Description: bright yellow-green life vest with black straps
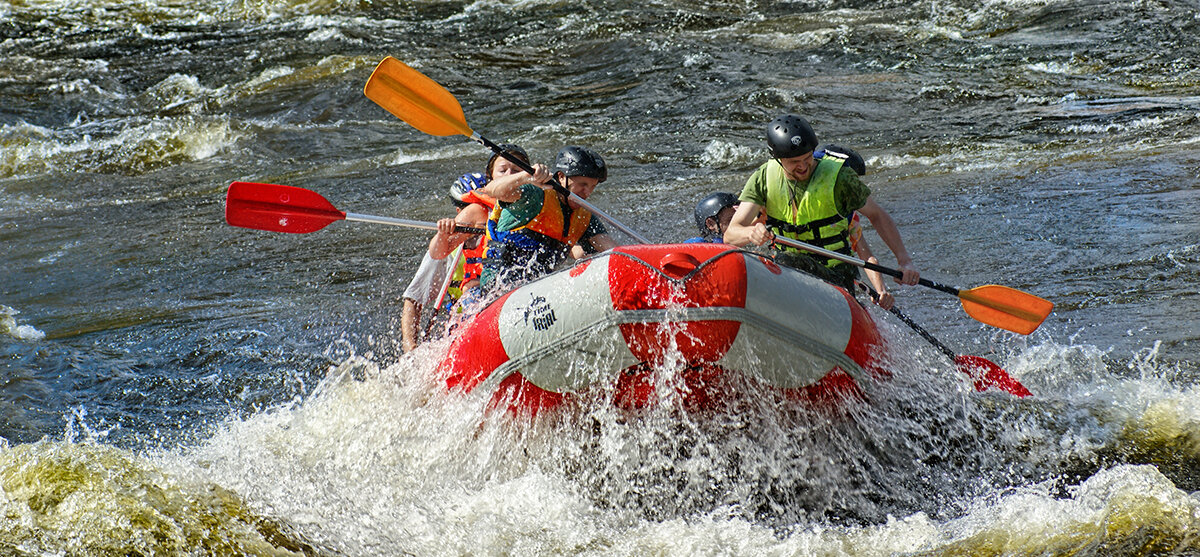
[[766, 155, 852, 268]]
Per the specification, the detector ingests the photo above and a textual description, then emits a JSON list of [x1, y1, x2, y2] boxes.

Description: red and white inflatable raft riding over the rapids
[[440, 244, 881, 413]]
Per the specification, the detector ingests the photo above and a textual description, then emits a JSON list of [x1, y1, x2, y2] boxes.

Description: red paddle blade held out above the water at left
[[226, 181, 346, 234]]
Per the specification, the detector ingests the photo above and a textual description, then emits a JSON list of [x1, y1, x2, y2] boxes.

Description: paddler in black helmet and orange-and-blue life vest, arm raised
[[482, 145, 617, 288]]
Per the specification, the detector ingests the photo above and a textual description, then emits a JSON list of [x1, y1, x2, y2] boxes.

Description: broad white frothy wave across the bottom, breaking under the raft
[[0, 328, 1200, 556]]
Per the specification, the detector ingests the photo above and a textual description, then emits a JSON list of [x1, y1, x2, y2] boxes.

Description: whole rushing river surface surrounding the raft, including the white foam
[[0, 0, 1200, 556]]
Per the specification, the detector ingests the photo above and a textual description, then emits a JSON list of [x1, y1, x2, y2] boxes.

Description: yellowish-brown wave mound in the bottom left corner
[[0, 441, 308, 556]]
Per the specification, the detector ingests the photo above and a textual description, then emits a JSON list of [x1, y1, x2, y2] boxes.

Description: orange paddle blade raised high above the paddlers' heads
[[362, 56, 474, 137]]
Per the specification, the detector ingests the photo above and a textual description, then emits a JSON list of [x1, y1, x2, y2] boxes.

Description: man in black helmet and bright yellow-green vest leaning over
[[725, 114, 920, 291]]
